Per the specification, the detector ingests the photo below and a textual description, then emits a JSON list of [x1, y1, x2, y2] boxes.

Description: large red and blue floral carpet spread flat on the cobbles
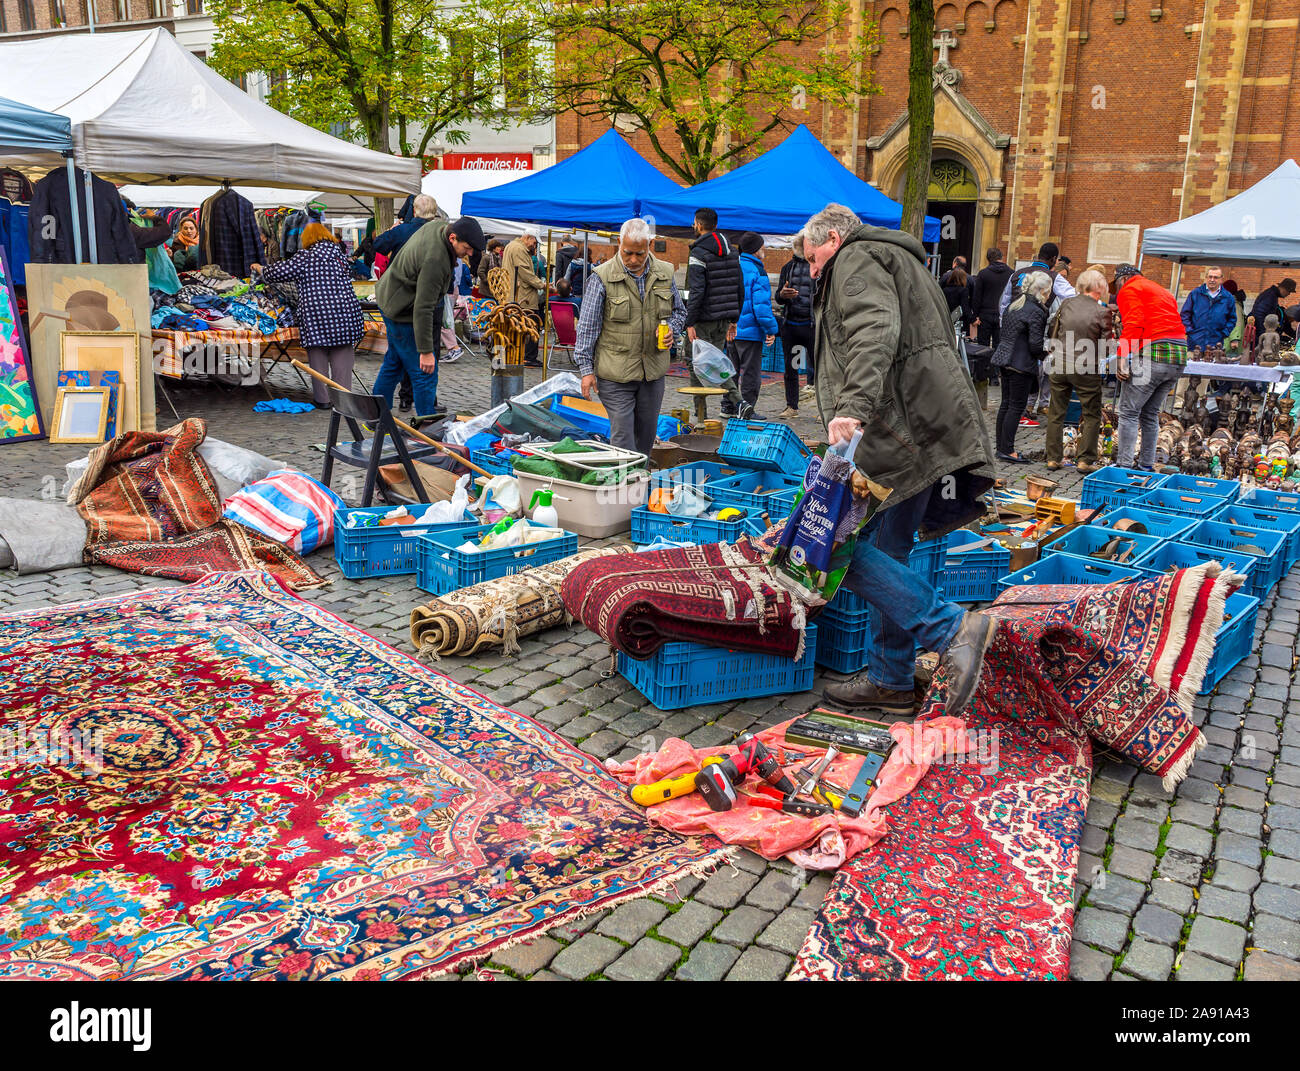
[[0, 572, 724, 979]]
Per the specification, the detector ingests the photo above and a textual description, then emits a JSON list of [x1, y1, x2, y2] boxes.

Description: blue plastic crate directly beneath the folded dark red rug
[[618, 624, 818, 710]]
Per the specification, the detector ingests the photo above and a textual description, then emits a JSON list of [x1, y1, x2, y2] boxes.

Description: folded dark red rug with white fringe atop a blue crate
[[560, 537, 805, 659]]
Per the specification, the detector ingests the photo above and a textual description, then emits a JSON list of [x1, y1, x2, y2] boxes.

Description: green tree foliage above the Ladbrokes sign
[[207, 0, 547, 156]]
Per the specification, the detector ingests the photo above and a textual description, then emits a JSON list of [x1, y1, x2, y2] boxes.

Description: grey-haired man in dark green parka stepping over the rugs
[[803, 204, 996, 715]]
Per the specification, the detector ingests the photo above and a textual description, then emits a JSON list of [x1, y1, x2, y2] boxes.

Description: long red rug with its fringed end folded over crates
[[792, 563, 1242, 979]]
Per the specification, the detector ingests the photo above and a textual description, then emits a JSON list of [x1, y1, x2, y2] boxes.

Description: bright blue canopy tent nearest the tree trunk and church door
[[641, 123, 940, 242]]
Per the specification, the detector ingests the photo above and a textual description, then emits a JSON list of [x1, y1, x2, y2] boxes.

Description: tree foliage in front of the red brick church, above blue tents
[[551, 0, 879, 183]]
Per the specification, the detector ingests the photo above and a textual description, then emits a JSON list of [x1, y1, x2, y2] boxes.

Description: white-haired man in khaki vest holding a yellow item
[[573, 218, 686, 454]]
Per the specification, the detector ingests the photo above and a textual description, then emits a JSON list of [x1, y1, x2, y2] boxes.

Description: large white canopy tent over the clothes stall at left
[[0, 27, 420, 196]]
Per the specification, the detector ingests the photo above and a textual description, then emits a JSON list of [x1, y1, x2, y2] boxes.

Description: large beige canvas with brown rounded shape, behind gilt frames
[[27, 264, 157, 432]]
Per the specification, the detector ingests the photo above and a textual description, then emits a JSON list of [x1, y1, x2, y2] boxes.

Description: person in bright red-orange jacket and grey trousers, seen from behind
[[1115, 264, 1187, 469]]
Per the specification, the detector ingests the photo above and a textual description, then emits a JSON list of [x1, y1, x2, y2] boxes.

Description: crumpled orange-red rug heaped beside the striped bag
[[68, 417, 326, 591]]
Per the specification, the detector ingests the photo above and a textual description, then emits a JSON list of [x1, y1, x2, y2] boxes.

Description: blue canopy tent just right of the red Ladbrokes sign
[[460, 130, 680, 230]]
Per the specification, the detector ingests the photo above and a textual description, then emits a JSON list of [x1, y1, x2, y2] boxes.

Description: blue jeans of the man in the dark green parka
[[844, 485, 965, 691]]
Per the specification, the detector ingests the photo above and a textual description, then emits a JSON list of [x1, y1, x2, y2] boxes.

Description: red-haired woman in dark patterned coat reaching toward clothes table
[[252, 224, 363, 409]]
